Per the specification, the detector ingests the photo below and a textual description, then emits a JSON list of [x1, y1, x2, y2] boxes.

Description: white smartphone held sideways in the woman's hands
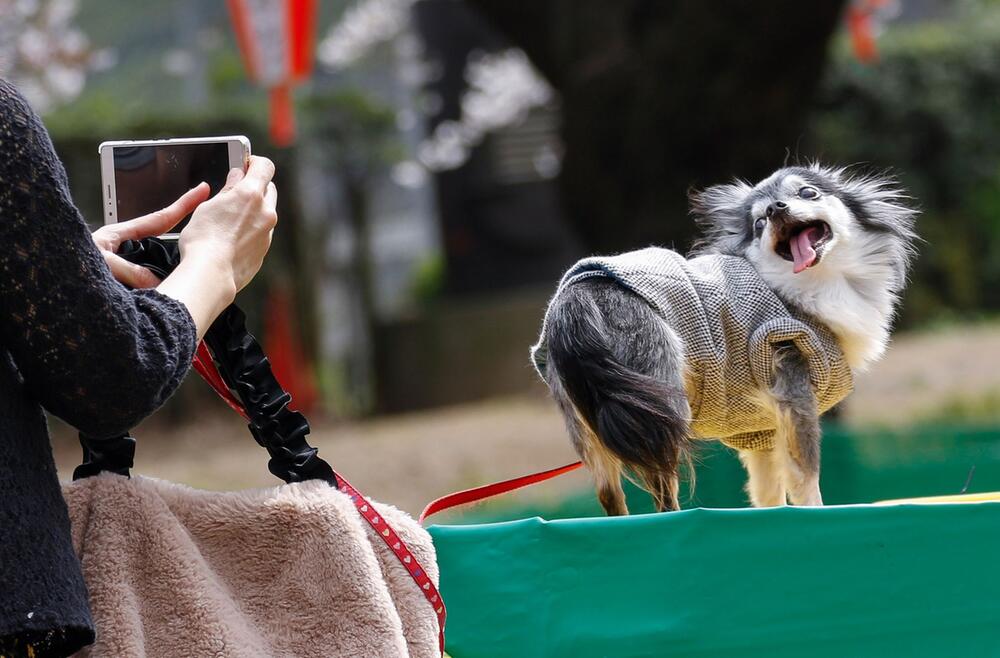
[[97, 135, 250, 239]]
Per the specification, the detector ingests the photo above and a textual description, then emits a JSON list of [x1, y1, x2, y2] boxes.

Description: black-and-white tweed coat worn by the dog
[[531, 247, 854, 450]]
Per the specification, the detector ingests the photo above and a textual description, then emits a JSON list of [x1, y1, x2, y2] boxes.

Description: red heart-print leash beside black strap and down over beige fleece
[[192, 341, 446, 655]]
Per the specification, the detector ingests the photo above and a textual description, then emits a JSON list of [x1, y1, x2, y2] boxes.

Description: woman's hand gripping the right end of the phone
[[180, 156, 278, 292]]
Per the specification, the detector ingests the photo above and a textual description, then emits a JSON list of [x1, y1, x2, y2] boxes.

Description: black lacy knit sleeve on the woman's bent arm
[[0, 80, 195, 436]]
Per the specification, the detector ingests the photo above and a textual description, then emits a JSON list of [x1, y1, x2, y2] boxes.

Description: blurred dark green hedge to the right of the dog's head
[[810, 10, 1000, 324]]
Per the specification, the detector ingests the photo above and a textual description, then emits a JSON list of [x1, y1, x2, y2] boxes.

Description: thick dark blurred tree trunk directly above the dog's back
[[466, 0, 845, 251]]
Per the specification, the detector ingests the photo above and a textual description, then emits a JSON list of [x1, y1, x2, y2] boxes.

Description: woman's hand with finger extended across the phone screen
[[91, 183, 209, 288]]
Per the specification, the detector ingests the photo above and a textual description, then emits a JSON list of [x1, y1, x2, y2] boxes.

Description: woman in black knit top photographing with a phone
[[0, 80, 277, 658]]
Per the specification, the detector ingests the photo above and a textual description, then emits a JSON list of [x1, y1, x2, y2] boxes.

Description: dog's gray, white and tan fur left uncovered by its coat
[[542, 164, 917, 514]]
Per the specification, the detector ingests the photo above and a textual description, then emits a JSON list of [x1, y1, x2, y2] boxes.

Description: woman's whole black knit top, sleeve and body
[[0, 80, 195, 657]]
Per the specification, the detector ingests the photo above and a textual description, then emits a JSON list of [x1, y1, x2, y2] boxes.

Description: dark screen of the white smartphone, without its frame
[[113, 142, 229, 233]]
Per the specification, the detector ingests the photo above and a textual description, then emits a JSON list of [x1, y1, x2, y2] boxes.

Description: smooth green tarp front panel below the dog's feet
[[430, 503, 1000, 658]]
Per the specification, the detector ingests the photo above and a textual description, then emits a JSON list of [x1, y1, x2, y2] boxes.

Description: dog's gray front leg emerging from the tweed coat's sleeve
[[771, 346, 823, 505]]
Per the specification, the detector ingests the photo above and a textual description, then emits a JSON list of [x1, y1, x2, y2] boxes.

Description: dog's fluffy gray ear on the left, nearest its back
[[688, 180, 753, 254]]
